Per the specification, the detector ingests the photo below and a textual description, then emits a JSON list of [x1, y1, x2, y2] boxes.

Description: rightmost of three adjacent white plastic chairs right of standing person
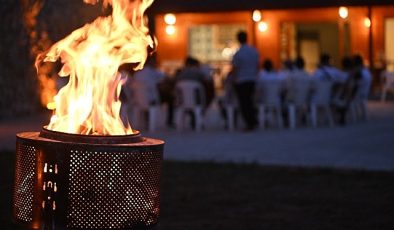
[[310, 80, 334, 127]]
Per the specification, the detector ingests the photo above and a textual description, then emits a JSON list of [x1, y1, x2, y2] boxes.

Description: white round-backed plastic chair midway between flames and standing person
[[175, 80, 205, 131]]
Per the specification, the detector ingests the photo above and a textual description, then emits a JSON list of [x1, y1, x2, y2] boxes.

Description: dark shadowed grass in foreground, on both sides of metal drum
[[0, 152, 394, 230]]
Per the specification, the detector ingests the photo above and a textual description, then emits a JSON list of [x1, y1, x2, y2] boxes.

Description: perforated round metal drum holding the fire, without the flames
[[13, 128, 164, 229]]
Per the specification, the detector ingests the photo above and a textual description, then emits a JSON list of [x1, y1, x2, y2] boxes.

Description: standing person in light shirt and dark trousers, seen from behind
[[232, 31, 259, 131]]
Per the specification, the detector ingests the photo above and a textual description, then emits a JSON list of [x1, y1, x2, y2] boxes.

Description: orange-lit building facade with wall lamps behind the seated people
[[154, 1, 394, 85]]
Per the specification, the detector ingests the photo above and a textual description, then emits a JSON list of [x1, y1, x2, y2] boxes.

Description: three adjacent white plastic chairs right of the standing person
[[240, 81, 334, 129]]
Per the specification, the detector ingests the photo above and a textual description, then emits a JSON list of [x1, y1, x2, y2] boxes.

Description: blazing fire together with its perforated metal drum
[[13, 0, 164, 229]]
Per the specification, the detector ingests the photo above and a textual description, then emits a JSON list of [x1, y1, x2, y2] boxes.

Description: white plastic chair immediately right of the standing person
[[256, 81, 283, 129]]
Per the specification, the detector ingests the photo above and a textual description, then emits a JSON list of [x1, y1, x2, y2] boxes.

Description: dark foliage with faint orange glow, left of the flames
[[0, 0, 103, 119]]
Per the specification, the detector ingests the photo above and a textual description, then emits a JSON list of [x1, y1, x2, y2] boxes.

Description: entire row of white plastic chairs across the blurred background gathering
[[124, 81, 367, 131]]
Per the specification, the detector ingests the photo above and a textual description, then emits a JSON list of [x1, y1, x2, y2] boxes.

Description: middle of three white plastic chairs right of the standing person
[[287, 79, 312, 129]]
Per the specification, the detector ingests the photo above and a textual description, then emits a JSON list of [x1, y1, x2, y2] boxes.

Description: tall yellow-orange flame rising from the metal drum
[[36, 0, 154, 135]]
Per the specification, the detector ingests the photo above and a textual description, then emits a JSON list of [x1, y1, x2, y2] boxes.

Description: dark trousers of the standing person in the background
[[235, 81, 257, 129]]
